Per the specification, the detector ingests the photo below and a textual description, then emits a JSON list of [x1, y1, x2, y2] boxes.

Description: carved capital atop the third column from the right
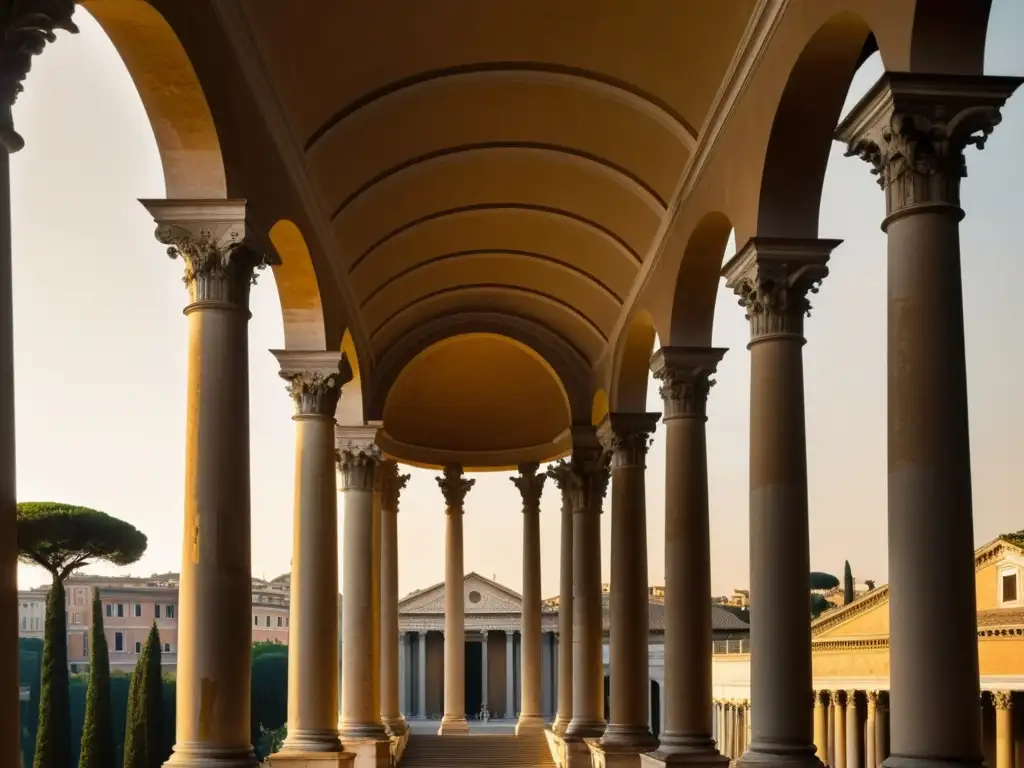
[[650, 347, 727, 421]]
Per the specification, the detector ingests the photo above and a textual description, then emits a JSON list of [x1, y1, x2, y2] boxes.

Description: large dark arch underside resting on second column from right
[[753, 11, 885, 239]]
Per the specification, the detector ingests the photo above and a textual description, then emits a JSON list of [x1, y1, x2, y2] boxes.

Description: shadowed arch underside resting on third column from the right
[[665, 211, 733, 346]]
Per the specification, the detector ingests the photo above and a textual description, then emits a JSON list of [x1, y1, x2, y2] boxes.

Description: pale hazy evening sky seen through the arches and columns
[[11, 0, 1024, 596]]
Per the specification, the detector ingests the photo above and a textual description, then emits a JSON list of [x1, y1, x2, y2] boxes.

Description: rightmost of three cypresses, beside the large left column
[[124, 622, 165, 768]]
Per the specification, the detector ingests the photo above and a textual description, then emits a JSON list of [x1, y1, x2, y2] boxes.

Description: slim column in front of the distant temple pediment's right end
[[509, 462, 548, 734]]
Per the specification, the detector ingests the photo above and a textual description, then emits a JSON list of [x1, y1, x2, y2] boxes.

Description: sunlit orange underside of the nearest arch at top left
[[81, 0, 227, 199]]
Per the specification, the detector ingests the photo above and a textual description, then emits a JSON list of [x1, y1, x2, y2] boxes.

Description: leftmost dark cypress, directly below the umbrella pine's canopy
[[33, 574, 71, 768]]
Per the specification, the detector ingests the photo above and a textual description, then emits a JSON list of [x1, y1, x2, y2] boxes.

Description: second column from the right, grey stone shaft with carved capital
[[723, 238, 840, 768]]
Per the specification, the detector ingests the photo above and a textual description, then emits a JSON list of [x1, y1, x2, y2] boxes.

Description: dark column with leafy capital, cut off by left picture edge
[[0, 7, 78, 766]]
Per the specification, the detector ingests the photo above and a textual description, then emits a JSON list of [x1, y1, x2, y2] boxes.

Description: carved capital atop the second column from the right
[[722, 238, 843, 341]]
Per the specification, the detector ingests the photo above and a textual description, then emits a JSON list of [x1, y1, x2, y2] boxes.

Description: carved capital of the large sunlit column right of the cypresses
[[139, 200, 267, 311]]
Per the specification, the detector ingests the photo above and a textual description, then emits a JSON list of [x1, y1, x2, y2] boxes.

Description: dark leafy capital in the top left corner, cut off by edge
[[0, 0, 78, 153]]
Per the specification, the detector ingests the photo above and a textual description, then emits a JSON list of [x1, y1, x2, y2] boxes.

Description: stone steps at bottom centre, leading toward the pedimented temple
[[399, 733, 555, 768]]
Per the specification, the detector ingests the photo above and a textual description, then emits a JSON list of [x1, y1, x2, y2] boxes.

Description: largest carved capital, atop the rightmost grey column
[[836, 72, 1024, 215]]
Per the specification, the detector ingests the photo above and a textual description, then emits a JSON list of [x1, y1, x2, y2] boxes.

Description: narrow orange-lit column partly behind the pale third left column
[[377, 461, 409, 735]]
